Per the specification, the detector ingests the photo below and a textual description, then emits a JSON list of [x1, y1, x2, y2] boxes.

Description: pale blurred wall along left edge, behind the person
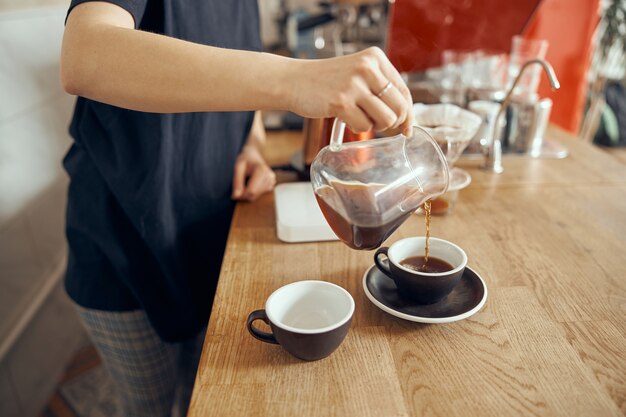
[[0, 6, 84, 417]]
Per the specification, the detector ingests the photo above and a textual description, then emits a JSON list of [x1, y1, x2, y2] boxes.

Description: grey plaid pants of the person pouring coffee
[[78, 307, 204, 417]]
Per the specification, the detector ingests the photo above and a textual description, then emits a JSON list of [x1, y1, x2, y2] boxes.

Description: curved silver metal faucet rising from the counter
[[483, 58, 561, 174]]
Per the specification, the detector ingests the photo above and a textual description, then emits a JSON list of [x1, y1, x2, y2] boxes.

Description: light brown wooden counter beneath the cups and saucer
[[189, 129, 626, 417]]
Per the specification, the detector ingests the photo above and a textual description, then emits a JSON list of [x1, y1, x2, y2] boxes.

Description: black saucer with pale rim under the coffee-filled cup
[[363, 265, 487, 323]]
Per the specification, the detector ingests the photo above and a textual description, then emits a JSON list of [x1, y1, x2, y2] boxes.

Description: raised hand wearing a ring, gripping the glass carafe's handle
[[287, 47, 413, 133]]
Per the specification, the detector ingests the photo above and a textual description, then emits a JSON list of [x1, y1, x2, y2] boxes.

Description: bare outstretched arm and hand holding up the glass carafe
[[61, 2, 411, 131]]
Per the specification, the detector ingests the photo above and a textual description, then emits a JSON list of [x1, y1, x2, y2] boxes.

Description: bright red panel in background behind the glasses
[[387, 0, 599, 133]]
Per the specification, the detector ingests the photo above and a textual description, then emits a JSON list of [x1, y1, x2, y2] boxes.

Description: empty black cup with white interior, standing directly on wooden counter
[[247, 281, 354, 361]]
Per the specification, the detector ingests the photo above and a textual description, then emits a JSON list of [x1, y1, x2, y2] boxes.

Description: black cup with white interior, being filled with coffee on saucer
[[374, 237, 467, 304]]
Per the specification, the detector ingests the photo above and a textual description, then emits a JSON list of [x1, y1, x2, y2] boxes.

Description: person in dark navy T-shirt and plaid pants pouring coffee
[[61, 0, 411, 416]]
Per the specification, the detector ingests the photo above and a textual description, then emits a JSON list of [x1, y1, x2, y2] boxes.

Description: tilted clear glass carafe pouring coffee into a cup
[[311, 119, 449, 250]]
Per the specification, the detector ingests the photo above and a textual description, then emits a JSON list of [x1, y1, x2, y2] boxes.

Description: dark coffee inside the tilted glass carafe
[[315, 181, 423, 250]]
